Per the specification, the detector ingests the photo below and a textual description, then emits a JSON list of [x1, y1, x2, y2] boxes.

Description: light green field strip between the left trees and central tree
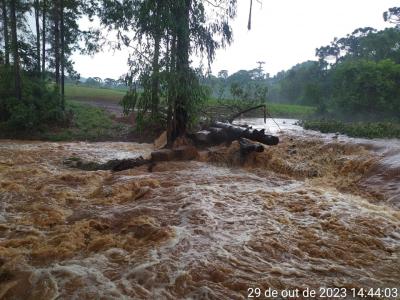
[[65, 84, 126, 103]]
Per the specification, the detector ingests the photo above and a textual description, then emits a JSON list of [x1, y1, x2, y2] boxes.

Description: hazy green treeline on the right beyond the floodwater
[[204, 23, 400, 118]]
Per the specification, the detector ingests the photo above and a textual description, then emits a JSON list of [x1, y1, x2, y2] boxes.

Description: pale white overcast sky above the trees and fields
[[73, 0, 400, 78]]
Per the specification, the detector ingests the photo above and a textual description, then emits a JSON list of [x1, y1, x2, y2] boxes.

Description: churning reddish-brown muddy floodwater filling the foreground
[[0, 120, 400, 299]]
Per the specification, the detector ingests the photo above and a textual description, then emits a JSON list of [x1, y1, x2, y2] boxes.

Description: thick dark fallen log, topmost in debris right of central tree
[[193, 122, 279, 146]]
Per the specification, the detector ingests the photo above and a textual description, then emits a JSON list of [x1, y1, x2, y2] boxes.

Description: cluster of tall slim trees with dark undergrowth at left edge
[[0, 0, 98, 131]]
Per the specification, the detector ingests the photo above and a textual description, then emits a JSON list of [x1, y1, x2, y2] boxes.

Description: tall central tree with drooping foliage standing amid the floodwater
[[99, 0, 236, 141]]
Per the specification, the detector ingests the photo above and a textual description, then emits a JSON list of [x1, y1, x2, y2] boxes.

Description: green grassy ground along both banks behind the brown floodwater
[[0, 85, 400, 142]]
